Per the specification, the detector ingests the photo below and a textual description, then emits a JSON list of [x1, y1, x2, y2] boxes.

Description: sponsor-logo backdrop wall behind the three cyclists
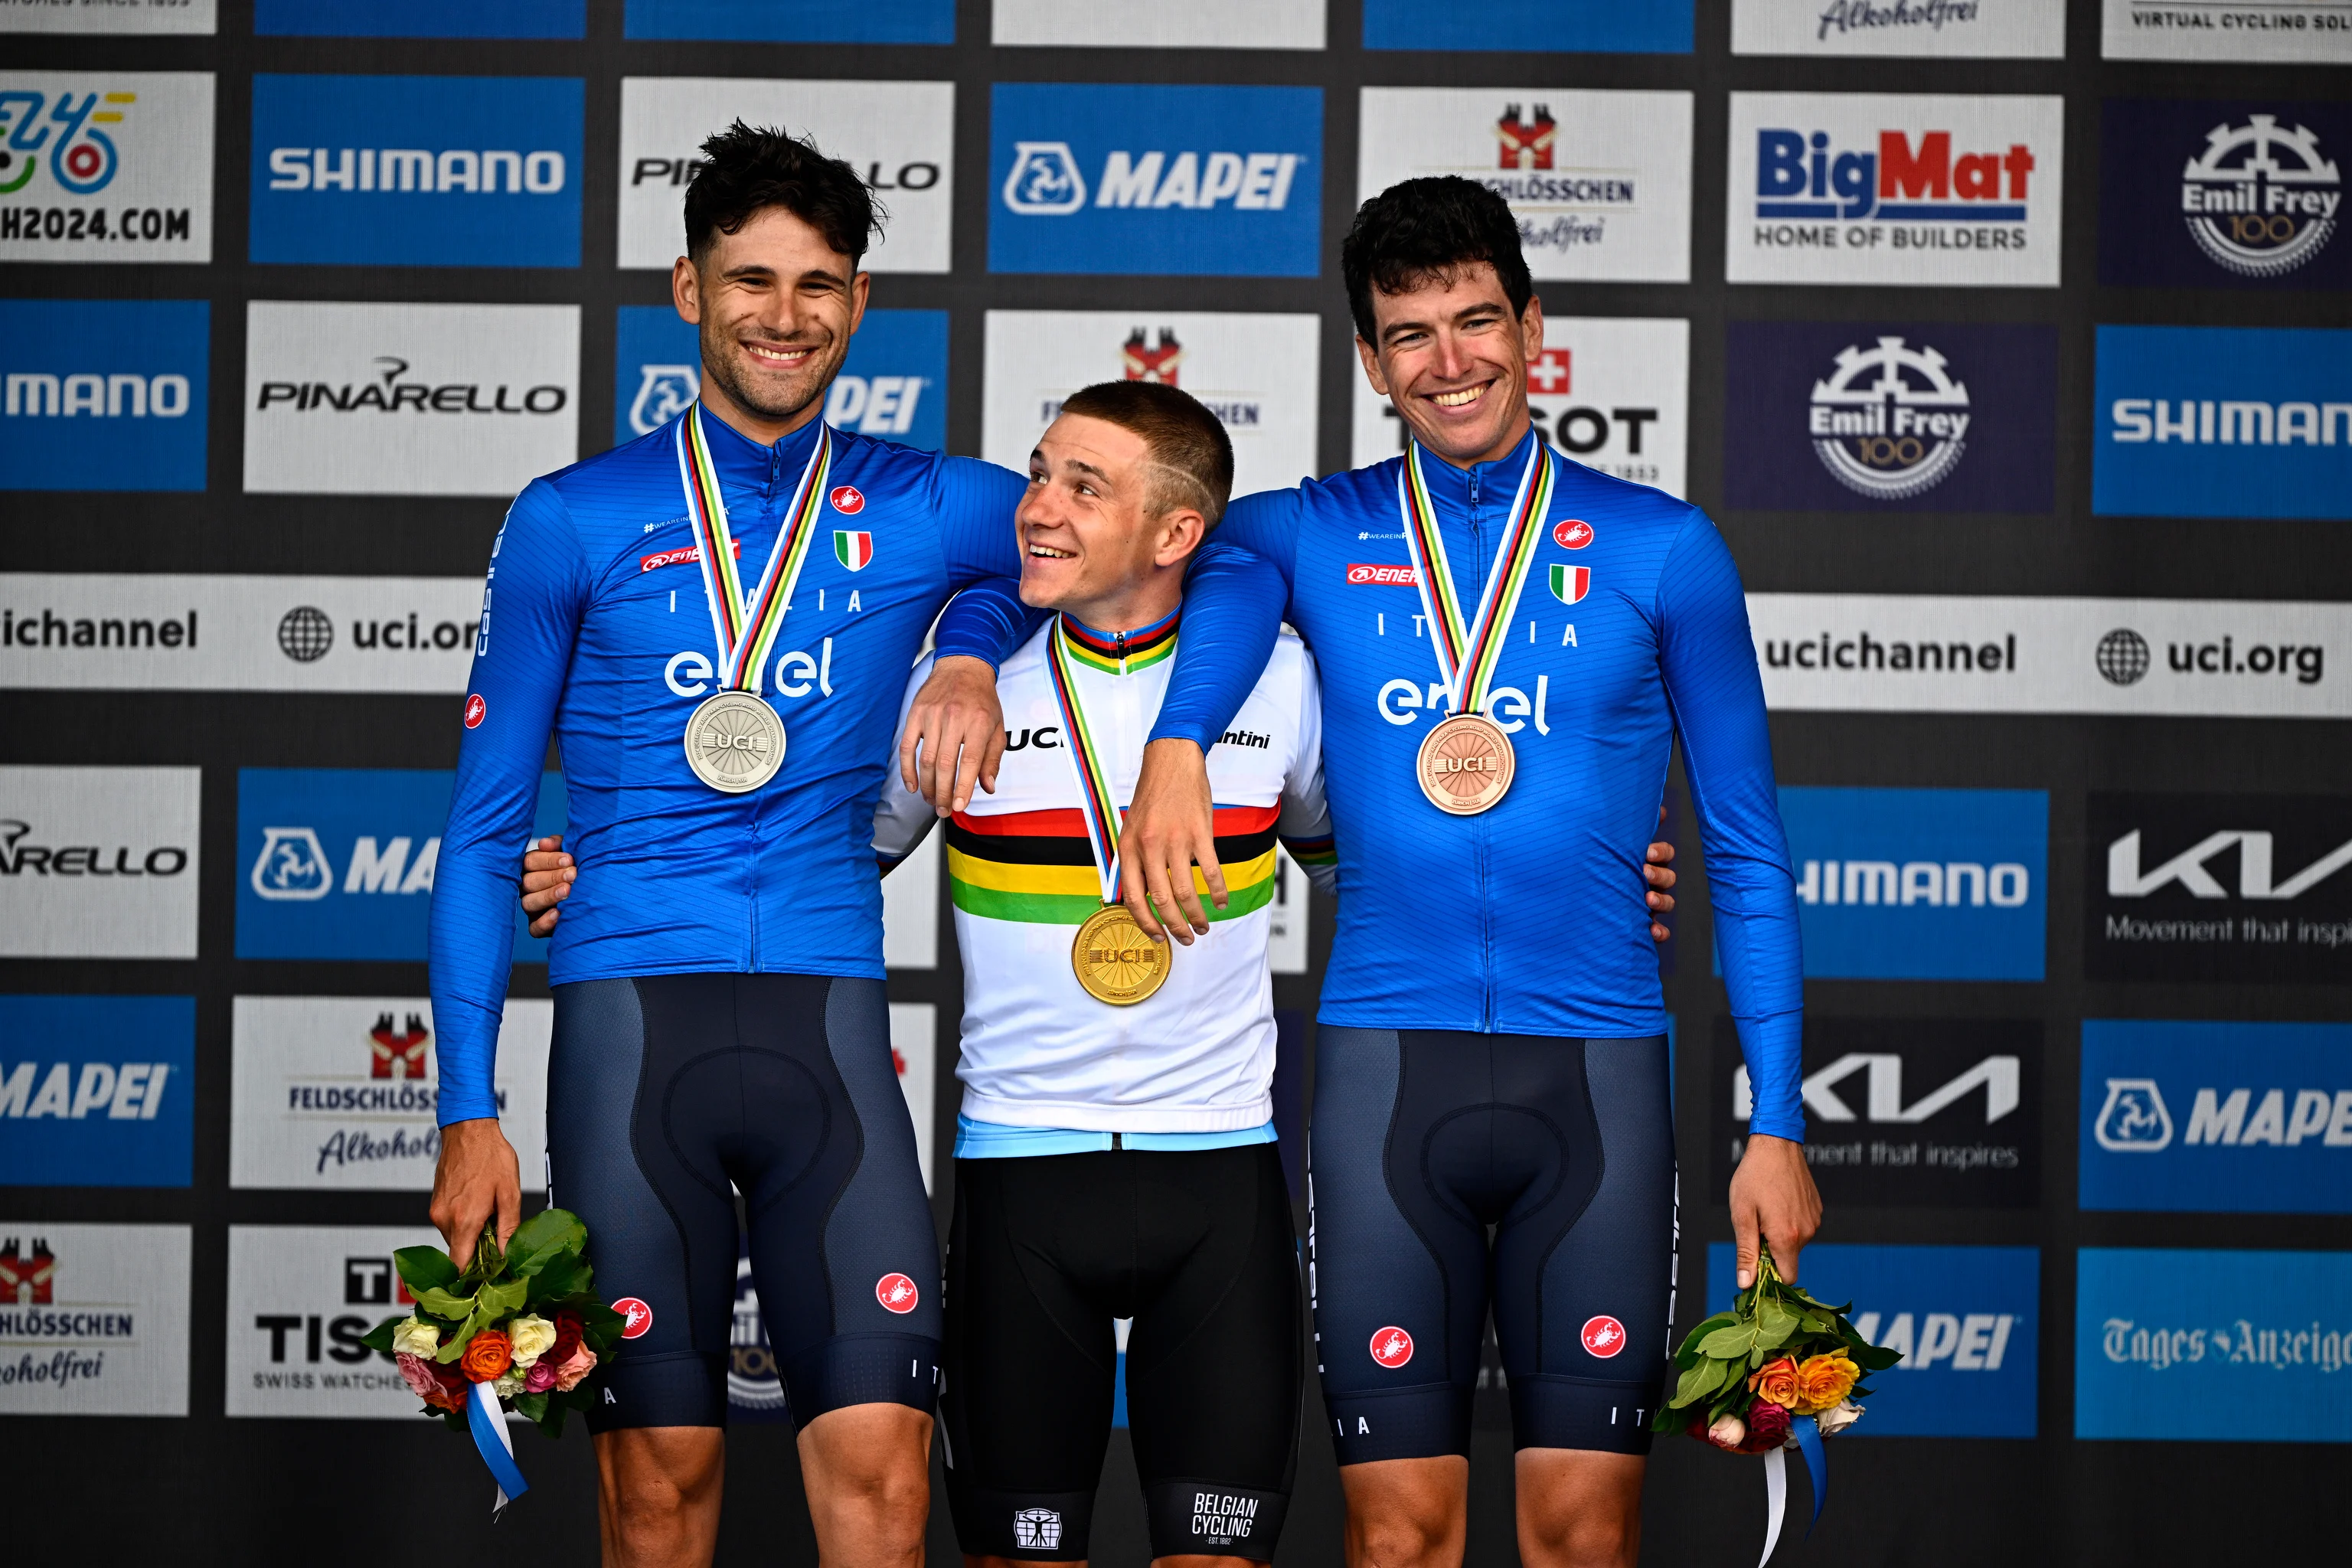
[[0, 0, 2352, 1568]]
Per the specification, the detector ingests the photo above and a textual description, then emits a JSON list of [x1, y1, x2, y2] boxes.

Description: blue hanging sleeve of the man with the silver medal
[[430, 482, 588, 1126]]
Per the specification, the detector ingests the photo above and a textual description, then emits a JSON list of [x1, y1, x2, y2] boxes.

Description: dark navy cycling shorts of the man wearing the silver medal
[[548, 973, 939, 1432]]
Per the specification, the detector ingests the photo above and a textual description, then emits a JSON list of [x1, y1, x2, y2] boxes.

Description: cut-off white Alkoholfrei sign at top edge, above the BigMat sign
[[1731, 0, 2065, 59]]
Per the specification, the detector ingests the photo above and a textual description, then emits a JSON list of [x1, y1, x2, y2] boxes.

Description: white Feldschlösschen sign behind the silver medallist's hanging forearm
[[228, 997, 555, 1192]]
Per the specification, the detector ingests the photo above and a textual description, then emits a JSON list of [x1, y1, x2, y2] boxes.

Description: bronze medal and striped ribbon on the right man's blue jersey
[[1397, 437, 1553, 815]]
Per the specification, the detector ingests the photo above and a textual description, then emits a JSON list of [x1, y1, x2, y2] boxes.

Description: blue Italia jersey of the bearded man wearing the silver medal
[[430, 419, 1282, 1126]]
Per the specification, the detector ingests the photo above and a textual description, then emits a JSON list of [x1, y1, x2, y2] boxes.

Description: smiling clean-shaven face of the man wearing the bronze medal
[[1354, 261, 1543, 466]]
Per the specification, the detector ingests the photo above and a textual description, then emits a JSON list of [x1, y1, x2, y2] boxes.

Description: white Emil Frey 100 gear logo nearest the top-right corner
[[2180, 115, 2343, 277]]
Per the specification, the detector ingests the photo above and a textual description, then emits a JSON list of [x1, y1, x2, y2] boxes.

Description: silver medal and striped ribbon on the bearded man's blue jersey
[[678, 402, 832, 795]]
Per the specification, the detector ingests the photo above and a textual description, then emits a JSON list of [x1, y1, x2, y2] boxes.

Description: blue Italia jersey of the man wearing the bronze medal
[[1204, 433, 1804, 1138]]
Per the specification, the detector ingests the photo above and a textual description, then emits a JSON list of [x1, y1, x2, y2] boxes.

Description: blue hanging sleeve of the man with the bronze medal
[[1658, 510, 1804, 1142]]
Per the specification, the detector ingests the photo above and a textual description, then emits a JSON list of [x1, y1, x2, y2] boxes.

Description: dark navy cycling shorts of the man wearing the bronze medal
[[1308, 1025, 1677, 1465]]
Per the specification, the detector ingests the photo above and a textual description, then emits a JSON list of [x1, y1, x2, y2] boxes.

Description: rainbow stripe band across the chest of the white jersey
[[948, 806, 1296, 926]]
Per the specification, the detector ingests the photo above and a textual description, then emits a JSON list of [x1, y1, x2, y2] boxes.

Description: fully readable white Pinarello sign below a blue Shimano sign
[[244, 301, 581, 501]]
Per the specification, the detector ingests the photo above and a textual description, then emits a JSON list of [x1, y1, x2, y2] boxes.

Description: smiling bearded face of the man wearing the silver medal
[[675, 207, 868, 435]]
